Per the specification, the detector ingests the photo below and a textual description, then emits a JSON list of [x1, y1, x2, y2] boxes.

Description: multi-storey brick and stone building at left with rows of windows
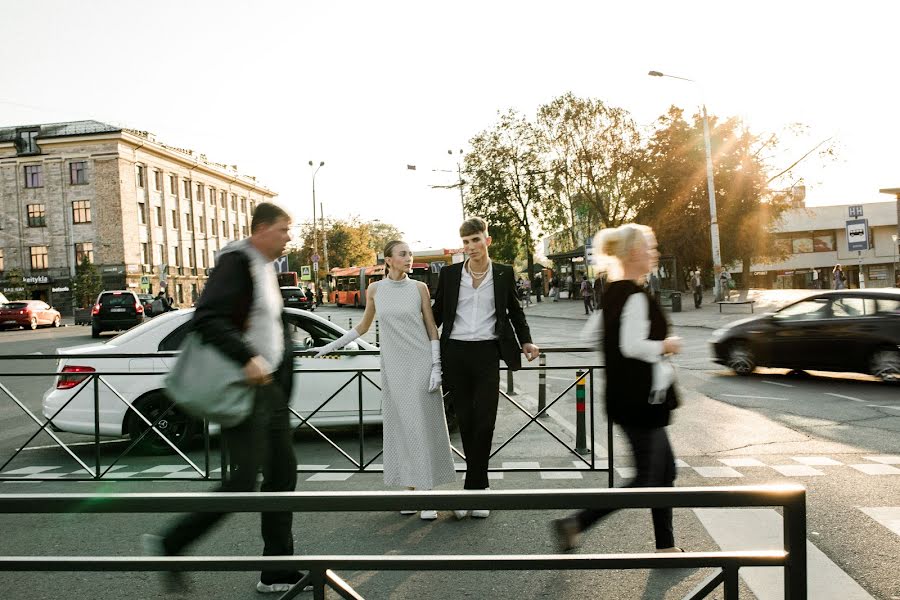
[[0, 121, 276, 314]]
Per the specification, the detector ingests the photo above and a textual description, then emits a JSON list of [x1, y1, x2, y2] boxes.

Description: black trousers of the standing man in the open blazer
[[441, 340, 500, 490]]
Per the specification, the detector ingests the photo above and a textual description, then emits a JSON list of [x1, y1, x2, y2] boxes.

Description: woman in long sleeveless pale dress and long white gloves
[[316, 241, 456, 520]]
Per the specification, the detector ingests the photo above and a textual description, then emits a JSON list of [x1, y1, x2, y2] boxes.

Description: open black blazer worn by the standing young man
[[431, 263, 531, 371]]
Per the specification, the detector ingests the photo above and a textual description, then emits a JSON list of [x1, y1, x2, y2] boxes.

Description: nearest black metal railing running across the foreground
[[0, 485, 807, 600]]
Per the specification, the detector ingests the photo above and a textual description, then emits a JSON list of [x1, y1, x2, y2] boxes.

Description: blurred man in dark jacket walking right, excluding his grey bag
[[143, 202, 303, 592]]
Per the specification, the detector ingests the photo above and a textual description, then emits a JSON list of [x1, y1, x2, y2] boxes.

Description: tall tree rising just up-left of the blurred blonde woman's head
[[538, 92, 645, 248]]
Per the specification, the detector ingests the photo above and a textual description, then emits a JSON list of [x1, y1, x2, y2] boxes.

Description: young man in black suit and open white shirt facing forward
[[432, 217, 540, 519]]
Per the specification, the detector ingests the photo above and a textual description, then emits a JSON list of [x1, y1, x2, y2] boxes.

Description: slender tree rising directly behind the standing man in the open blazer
[[465, 110, 551, 273]]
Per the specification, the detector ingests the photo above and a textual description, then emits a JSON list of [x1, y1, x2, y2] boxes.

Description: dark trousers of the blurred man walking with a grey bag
[[163, 384, 297, 583]]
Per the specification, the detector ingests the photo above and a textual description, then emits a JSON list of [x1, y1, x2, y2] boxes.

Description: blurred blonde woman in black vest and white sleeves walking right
[[553, 224, 681, 552]]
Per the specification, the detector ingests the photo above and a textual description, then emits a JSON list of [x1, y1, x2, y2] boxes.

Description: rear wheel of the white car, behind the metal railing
[[127, 390, 197, 454]]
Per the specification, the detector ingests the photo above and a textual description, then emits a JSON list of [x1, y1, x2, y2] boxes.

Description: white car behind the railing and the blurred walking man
[[43, 308, 381, 452]]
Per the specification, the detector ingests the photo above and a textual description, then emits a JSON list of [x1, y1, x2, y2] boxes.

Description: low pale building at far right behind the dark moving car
[[728, 200, 900, 289]]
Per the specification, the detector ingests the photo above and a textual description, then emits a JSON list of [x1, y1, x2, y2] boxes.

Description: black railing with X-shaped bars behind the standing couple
[[0, 347, 614, 487]]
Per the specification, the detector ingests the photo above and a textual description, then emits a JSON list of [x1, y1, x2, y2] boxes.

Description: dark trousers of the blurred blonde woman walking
[[575, 426, 675, 548]]
